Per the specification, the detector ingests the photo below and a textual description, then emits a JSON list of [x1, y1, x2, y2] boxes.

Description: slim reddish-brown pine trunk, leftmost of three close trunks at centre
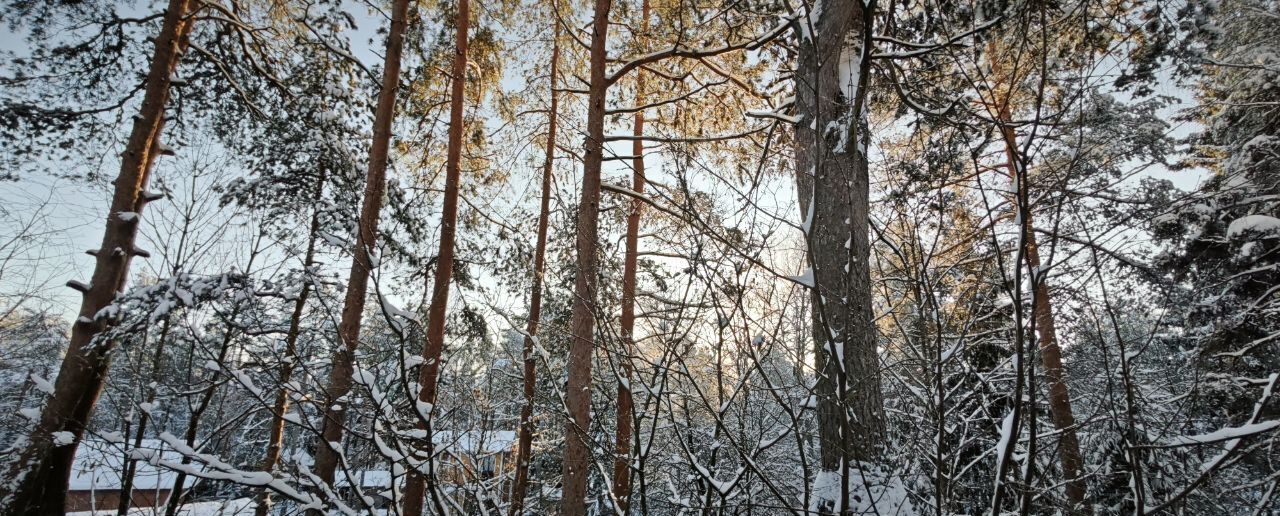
[[511, 23, 559, 516]]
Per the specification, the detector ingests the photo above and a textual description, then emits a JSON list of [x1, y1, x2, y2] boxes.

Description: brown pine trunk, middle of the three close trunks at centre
[[562, 0, 612, 516]]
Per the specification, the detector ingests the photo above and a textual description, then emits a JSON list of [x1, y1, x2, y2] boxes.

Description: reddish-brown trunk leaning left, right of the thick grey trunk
[[1000, 115, 1092, 513]]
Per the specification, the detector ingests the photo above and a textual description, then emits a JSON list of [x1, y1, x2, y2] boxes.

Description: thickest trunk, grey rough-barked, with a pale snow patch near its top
[[796, 1, 884, 511]]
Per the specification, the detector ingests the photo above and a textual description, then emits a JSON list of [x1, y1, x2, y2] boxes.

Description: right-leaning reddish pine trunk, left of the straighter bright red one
[[315, 0, 408, 501]]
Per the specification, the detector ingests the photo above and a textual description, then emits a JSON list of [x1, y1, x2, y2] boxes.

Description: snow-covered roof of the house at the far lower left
[[68, 439, 196, 490]]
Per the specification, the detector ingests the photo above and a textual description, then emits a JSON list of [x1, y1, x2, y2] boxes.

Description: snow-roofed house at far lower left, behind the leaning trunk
[[65, 439, 196, 512]]
